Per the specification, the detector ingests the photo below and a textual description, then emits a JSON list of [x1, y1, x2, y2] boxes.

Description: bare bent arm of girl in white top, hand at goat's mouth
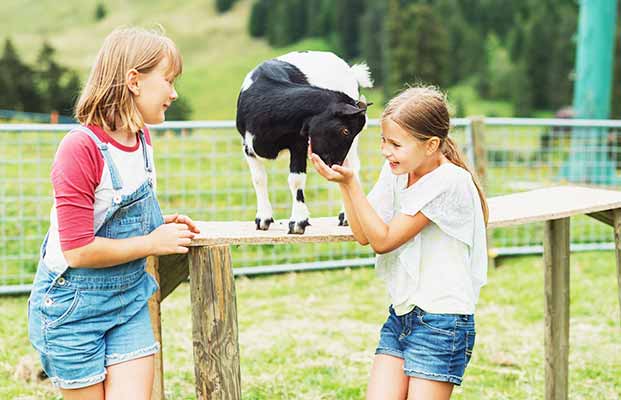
[[310, 153, 429, 254]]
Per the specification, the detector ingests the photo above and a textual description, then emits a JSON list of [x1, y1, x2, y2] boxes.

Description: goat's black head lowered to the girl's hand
[[302, 99, 370, 165]]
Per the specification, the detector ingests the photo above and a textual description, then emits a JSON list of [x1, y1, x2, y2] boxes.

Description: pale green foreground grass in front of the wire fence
[[0, 252, 621, 400]]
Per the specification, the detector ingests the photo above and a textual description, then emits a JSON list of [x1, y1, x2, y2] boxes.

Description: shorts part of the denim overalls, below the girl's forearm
[[28, 262, 159, 389]]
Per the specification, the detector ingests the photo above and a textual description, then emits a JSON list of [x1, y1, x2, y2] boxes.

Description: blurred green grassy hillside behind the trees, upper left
[[0, 0, 381, 120]]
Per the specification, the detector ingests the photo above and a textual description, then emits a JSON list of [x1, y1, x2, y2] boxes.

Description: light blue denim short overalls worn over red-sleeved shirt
[[28, 127, 164, 389]]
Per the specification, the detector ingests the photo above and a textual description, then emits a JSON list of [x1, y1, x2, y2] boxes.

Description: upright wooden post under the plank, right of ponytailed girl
[[543, 218, 569, 400]]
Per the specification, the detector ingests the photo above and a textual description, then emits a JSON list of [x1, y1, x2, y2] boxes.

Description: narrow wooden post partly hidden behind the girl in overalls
[[146, 257, 165, 400]]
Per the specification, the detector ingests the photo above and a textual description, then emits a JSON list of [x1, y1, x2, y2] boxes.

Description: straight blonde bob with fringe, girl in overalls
[[75, 28, 183, 132]]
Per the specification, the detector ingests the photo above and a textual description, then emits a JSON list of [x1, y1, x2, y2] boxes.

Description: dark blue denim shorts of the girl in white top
[[375, 306, 475, 385]]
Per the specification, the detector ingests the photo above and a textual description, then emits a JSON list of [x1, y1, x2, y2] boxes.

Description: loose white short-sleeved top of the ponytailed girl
[[368, 163, 487, 315]]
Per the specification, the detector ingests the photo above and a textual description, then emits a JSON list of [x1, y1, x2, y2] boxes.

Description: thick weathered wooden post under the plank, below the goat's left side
[[189, 246, 241, 400]]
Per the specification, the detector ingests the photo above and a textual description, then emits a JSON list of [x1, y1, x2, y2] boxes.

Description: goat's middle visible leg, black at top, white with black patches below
[[288, 142, 310, 234]]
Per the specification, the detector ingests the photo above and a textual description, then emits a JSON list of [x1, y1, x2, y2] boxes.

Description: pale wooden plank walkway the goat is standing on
[[191, 186, 621, 246]]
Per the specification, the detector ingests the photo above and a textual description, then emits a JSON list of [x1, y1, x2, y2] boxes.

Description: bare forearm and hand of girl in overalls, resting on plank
[[63, 214, 199, 268]]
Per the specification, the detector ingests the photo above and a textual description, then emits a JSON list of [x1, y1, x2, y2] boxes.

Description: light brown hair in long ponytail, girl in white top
[[382, 86, 489, 225]]
